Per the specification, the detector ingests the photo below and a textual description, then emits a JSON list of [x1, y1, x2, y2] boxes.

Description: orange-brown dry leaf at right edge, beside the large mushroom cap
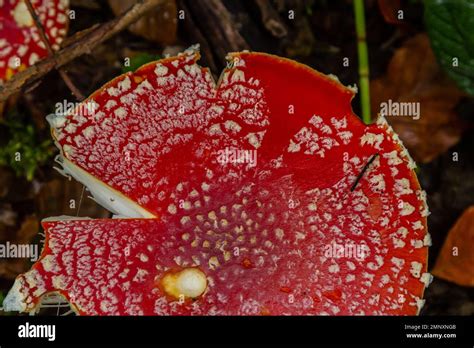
[[432, 206, 474, 286]]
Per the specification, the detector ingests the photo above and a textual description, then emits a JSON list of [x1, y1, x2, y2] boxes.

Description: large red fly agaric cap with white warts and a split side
[[4, 49, 431, 315]]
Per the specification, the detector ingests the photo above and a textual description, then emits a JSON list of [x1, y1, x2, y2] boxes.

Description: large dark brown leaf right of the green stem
[[370, 34, 464, 163]]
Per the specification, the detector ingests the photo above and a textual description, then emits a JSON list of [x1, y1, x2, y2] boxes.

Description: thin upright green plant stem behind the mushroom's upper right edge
[[353, 0, 371, 124]]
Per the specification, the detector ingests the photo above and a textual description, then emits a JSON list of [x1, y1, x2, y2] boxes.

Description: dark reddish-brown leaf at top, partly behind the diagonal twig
[[109, 0, 178, 45]]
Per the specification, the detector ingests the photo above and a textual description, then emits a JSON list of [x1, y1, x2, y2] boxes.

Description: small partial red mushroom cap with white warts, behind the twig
[[0, 0, 69, 84]]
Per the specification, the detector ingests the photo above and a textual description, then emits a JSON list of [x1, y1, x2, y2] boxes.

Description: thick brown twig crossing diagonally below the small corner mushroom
[[0, 0, 164, 102]]
